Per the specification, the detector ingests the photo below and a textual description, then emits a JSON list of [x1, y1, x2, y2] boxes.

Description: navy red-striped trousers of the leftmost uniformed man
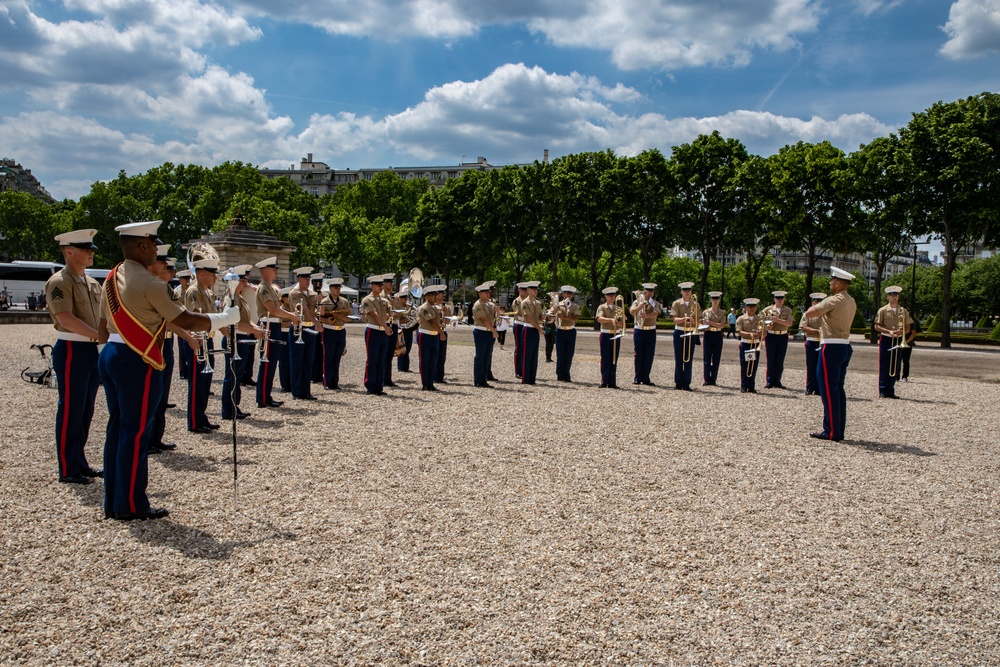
[[52, 340, 101, 477]]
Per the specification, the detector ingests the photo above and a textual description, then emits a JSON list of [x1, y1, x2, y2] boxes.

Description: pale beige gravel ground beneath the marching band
[[0, 325, 1000, 665]]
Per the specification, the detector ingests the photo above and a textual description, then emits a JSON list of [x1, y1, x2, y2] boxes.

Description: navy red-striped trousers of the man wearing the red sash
[[97, 343, 162, 514]]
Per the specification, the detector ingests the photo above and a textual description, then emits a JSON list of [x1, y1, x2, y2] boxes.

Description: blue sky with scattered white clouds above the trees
[[0, 0, 1000, 204]]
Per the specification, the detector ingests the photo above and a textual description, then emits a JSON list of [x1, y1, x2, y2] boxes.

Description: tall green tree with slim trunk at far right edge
[[899, 93, 1000, 348]]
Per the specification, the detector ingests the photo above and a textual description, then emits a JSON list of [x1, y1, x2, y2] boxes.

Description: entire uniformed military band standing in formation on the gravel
[[46, 221, 915, 521]]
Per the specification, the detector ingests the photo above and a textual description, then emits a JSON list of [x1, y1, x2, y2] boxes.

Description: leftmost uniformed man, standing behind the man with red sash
[[45, 229, 103, 484]]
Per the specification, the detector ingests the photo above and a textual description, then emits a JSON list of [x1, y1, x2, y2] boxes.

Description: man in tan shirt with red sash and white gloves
[[98, 221, 239, 521]]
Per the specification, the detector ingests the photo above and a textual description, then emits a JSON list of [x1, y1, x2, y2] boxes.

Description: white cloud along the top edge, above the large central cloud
[[236, 0, 820, 70]]
